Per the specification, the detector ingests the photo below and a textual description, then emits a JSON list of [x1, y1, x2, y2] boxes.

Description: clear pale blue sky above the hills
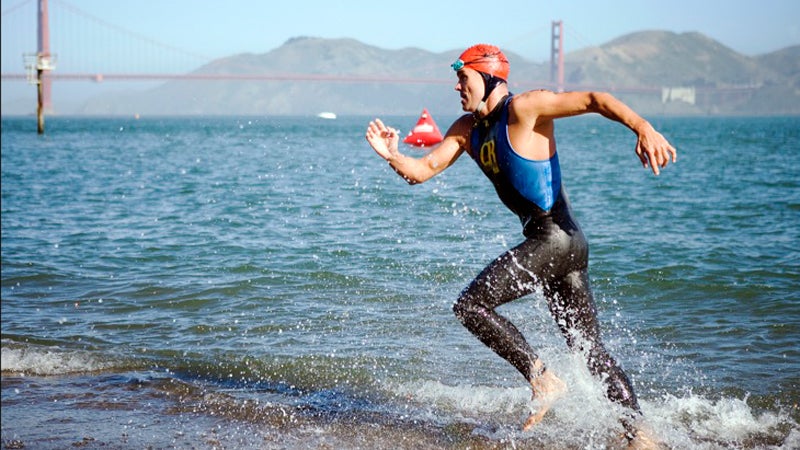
[[0, 0, 800, 62]]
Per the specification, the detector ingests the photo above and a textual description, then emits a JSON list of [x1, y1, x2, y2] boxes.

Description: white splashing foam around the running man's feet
[[386, 357, 800, 450]]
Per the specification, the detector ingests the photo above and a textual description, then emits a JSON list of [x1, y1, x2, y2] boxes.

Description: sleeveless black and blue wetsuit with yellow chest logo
[[453, 96, 639, 412]]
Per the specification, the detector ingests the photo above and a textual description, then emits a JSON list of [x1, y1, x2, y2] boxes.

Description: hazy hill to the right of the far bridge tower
[[565, 31, 800, 115]]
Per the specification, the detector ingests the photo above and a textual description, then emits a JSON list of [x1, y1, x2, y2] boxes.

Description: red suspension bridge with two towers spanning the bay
[[0, 0, 756, 132]]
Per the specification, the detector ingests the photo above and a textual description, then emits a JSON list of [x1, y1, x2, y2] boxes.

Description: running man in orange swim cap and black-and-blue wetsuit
[[366, 44, 676, 445]]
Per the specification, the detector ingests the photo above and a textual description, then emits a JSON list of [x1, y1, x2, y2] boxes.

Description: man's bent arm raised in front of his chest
[[366, 116, 469, 184]]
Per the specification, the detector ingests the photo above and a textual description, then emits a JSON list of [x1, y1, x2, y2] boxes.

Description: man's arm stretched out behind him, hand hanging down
[[512, 91, 677, 175]]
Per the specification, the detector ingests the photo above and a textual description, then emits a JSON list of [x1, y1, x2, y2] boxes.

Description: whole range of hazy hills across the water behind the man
[[73, 31, 800, 115]]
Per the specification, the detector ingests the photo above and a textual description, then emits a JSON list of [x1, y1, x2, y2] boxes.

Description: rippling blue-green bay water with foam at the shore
[[2, 116, 800, 449]]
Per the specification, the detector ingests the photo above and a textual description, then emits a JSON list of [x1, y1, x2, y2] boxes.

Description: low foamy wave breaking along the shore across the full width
[[2, 339, 800, 449]]
